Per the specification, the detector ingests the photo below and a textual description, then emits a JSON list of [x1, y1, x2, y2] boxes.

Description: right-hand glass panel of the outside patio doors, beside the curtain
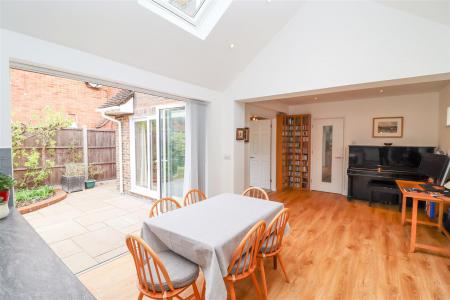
[[159, 107, 185, 199]]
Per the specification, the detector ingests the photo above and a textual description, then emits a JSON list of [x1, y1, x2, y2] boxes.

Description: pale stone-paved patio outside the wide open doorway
[[24, 182, 151, 274]]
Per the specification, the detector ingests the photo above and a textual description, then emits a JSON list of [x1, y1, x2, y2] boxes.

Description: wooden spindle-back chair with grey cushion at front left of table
[[126, 235, 201, 300]]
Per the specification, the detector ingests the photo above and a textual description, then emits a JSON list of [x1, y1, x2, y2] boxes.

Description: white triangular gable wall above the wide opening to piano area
[[227, 1, 450, 99]]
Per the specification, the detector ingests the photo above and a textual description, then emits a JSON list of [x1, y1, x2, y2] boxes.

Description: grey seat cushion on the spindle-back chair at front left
[[146, 251, 199, 292]]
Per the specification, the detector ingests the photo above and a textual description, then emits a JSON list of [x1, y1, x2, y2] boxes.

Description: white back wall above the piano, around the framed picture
[[290, 93, 439, 194]]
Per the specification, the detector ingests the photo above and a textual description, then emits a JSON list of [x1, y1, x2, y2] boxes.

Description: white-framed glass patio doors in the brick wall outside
[[131, 105, 185, 199]]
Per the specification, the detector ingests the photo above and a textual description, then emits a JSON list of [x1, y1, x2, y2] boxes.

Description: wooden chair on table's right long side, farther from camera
[[258, 208, 289, 299]]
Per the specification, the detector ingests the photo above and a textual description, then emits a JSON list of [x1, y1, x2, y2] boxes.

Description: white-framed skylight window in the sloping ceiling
[[137, 0, 232, 40]]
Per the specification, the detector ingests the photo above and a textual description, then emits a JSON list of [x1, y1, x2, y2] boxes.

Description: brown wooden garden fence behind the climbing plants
[[14, 129, 116, 185]]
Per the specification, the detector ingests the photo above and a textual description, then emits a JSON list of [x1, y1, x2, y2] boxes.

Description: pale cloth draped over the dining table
[[141, 194, 283, 300]]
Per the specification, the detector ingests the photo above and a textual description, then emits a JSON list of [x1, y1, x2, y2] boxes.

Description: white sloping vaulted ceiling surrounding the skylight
[[0, 0, 450, 91]]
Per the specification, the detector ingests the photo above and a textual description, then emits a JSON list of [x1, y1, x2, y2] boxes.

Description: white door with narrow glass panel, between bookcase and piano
[[311, 119, 344, 194]]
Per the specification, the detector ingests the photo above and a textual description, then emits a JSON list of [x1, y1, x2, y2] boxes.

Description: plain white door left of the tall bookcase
[[249, 120, 272, 189]]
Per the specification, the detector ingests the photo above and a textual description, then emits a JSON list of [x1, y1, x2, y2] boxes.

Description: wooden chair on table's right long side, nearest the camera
[[224, 221, 266, 300]]
